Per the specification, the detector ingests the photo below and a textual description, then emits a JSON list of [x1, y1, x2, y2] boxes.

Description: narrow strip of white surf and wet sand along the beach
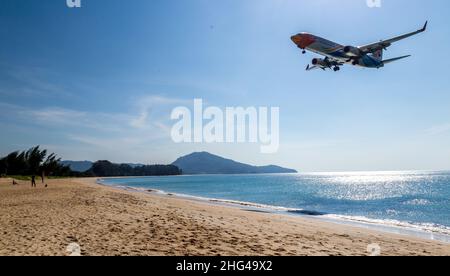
[[96, 177, 450, 244]]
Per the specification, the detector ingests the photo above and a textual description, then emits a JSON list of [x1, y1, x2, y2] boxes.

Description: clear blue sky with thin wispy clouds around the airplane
[[0, 0, 450, 172]]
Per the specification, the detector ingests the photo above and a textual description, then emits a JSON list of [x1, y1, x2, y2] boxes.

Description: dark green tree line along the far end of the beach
[[0, 146, 182, 177]]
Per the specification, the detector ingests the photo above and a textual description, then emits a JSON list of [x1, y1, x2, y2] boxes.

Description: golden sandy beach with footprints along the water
[[0, 179, 450, 256]]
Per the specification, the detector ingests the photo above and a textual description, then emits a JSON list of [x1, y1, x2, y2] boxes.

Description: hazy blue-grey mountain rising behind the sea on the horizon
[[172, 152, 297, 174]]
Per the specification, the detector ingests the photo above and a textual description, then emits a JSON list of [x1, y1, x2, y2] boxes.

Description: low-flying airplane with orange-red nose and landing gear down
[[291, 21, 428, 72]]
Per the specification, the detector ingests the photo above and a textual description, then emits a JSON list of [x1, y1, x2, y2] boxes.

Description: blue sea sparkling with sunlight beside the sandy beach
[[100, 171, 450, 242]]
